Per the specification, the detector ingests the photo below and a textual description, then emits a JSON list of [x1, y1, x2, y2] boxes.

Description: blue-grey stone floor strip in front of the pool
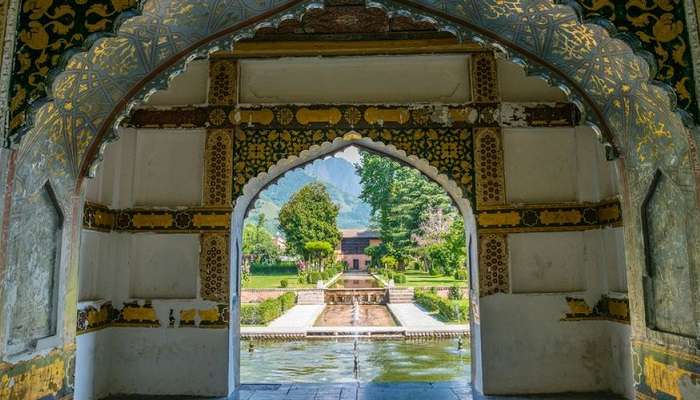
[[238, 382, 621, 400]]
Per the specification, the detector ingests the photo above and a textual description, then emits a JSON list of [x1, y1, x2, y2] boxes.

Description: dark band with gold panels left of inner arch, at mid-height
[[83, 202, 232, 233]]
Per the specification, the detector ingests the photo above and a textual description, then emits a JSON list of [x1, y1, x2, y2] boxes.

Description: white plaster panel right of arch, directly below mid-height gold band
[[508, 232, 592, 293]]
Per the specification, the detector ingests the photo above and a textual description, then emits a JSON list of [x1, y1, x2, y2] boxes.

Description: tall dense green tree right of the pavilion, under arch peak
[[355, 152, 454, 266]]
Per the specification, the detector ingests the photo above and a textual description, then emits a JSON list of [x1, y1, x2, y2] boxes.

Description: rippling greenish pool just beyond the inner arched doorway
[[241, 339, 471, 383]]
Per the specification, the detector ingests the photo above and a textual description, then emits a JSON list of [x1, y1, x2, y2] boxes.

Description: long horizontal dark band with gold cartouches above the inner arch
[[123, 103, 581, 130]]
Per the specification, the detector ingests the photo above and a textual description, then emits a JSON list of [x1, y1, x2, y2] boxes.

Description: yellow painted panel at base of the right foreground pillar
[[632, 340, 700, 400]]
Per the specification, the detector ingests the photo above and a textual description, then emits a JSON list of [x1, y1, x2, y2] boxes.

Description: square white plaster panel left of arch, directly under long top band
[[133, 129, 206, 206]]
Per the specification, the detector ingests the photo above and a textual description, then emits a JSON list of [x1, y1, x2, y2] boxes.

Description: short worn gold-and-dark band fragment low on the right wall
[[561, 295, 630, 324]]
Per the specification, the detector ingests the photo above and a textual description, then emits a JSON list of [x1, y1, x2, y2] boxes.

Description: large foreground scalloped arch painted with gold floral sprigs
[[2, 0, 696, 203]]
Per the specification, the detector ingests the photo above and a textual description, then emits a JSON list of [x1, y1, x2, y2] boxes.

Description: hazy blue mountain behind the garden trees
[[246, 157, 370, 233]]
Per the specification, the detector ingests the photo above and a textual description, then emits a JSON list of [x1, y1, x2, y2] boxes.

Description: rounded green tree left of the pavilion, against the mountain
[[279, 182, 341, 259]]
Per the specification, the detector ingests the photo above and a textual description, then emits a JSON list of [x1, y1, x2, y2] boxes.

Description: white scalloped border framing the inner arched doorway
[[228, 131, 482, 398]]
